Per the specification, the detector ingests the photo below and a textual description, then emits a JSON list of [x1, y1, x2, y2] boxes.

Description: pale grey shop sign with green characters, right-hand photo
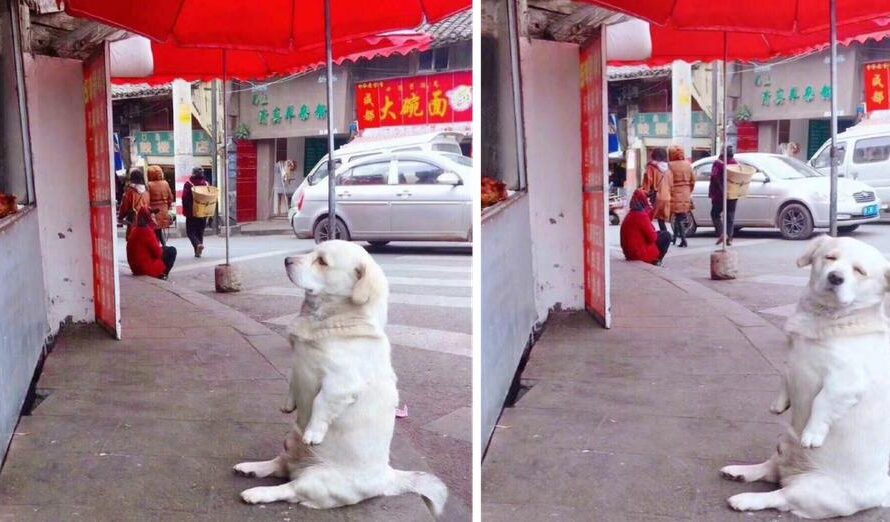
[[730, 49, 859, 121]]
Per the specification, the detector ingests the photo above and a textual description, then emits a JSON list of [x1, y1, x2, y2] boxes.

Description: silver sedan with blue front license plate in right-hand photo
[[688, 152, 881, 239]]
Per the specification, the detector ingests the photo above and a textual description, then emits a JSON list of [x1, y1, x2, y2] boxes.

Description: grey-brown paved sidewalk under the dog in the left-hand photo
[[0, 274, 444, 522]]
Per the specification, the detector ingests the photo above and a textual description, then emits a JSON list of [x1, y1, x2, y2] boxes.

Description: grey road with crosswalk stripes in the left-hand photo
[[153, 234, 472, 516]]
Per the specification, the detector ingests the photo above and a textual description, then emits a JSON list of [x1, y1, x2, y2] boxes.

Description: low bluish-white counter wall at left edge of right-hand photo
[[480, 194, 537, 443]]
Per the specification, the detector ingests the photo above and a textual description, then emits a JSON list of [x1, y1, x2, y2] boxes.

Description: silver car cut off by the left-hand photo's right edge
[[290, 152, 478, 245]]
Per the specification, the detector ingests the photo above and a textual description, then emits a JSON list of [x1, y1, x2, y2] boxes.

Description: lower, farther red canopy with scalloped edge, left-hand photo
[[113, 34, 432, 85]]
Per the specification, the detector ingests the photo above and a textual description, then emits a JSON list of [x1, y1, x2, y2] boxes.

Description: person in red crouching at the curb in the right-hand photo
[[621, 189, 671, 265]]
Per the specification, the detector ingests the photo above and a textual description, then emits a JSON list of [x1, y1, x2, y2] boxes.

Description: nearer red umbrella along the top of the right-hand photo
[[580, 0, 890, 34]]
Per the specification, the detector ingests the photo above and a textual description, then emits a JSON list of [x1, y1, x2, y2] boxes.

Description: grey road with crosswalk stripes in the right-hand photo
[[609, 223, 890, 328]]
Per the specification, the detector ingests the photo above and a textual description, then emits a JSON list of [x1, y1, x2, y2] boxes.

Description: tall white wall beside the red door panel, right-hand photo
[[516, 39, 584, 314]]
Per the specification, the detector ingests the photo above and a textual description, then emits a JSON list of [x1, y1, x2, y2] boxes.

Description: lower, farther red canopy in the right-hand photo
[[609, 21, 890, 65]]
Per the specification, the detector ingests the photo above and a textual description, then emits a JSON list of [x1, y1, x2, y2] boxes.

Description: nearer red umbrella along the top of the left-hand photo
[[66, 0, 472, 52]]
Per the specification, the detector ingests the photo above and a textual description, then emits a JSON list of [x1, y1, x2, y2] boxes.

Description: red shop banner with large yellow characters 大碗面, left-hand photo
[[355, 71, 473, 129]]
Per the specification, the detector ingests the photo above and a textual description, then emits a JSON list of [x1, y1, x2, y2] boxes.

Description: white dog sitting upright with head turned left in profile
[[235, 241, 448, 516]]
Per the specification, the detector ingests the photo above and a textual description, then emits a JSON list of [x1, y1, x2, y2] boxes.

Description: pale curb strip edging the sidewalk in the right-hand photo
[[635, 263, 788, 371]]
